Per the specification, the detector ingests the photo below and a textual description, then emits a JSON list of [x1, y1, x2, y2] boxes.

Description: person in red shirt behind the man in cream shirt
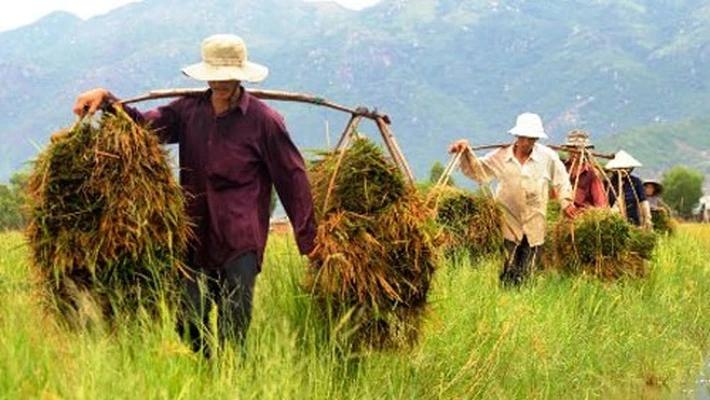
[[564, 129, 608, 209]]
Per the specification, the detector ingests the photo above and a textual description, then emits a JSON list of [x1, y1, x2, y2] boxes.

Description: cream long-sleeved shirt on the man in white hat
[[461, 143, 572, 246]]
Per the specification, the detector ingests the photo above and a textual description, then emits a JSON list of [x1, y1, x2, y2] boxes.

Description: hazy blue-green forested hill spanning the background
[[0, 0, 710, 180]]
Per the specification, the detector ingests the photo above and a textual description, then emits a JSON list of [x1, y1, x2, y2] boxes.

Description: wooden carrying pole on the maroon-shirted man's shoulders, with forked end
[[117, 88, 415, 185]]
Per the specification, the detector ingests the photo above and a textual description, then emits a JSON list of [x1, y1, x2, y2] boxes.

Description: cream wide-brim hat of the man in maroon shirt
[[182, 34, 269, 83]]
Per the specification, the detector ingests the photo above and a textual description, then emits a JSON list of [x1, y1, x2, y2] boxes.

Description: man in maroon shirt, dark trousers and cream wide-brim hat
[[74, 34, 316, 355]]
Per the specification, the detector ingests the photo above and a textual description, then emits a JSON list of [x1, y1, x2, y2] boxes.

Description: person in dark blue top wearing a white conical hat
[[604, 150, 653, 229]]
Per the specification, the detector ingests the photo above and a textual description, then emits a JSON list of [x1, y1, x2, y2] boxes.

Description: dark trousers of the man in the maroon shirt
[[178, 252, 259, 357]]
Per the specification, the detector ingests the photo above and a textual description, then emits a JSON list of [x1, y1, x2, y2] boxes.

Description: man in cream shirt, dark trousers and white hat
[[449, 113, 576, 286]]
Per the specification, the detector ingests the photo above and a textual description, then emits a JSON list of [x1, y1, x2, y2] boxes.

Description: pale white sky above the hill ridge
[[0, 0, 380, 31]]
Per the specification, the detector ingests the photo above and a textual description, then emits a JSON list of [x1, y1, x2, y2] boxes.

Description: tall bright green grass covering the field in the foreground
[[0, 225, 710, 400]]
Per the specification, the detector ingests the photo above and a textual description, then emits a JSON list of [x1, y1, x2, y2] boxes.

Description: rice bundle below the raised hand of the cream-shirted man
[[429, 186, 503, 262]]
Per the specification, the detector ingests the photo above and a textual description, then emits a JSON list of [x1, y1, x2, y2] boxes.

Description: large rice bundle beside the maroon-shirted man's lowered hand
[[306, 139, 437, 349]]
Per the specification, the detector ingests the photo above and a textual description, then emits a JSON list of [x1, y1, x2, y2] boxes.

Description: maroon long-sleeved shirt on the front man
[[125, 90, 316, 269]]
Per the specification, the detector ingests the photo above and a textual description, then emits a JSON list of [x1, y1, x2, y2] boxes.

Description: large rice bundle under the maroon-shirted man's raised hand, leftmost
[[26, 109, 190, 320]]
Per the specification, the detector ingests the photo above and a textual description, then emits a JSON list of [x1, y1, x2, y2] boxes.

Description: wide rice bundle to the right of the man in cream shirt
[[545, 208, 656, 279]]
